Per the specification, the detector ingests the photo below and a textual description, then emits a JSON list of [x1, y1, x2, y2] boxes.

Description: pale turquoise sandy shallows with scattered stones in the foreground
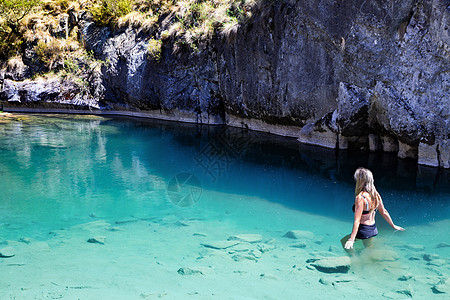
[[0, 191, 450, 299]]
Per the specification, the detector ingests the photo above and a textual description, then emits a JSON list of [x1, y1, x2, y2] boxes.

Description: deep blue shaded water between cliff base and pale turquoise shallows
[[108, 118, 450, 224]]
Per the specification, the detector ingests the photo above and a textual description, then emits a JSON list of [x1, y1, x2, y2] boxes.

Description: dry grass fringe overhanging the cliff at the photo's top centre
[[89, 0, 261, 55]]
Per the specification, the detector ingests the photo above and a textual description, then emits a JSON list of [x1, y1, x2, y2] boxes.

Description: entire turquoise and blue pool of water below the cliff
[[0, 115, 450, 299]]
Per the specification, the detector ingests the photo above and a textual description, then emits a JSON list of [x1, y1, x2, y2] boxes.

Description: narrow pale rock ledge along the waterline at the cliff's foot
[[0, 102, 450, 168]]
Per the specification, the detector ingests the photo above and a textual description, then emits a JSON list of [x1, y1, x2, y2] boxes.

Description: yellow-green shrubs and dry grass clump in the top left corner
[[0, 0, 111, 90]]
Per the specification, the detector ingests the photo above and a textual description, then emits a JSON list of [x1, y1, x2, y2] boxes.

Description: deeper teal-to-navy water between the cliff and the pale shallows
[[0, 115, 450, 298]]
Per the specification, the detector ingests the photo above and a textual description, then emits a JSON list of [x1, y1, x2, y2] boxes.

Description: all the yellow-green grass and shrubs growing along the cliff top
[[0, 0, 260, 77]]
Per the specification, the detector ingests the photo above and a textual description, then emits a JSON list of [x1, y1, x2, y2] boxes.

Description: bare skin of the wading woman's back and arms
[[341, 191, 405, 249]]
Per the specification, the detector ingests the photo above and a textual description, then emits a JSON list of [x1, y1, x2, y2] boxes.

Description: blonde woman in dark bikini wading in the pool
[[341, 168, 405, 249]]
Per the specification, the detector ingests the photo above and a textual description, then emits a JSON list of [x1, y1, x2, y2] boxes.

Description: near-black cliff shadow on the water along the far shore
[[115, 117, 450, 193]]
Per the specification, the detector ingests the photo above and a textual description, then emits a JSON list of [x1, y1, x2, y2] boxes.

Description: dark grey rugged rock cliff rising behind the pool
[[0, 0, 450, 168]]
